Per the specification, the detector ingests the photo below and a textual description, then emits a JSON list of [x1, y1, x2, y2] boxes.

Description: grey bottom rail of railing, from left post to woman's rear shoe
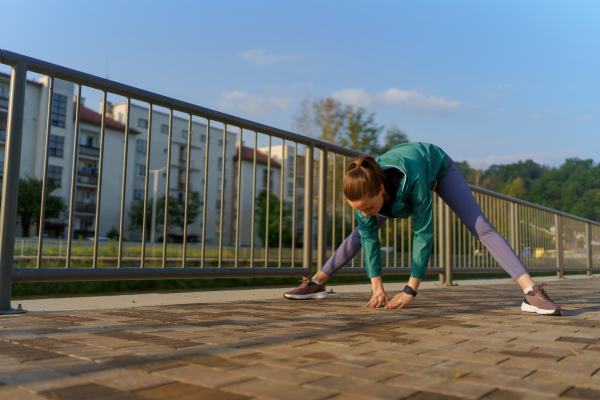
[[11, 267, 310, 283]]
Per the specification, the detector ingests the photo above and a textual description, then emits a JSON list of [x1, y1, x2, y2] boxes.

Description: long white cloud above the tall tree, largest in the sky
[[331, 88, 463, 114]]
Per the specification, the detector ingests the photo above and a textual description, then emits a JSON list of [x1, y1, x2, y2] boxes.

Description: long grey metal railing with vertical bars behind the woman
[[0, 50, 600, 312]]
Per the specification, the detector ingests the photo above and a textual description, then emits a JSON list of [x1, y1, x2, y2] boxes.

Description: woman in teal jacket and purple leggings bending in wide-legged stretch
[[284, 143, 561, 315]]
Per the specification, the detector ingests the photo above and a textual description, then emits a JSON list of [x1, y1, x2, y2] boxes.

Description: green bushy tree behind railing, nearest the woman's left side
[[255, 190, 293, 248]]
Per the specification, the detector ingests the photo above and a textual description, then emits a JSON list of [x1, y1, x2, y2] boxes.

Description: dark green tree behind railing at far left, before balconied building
[[17, 176, 67, 237]]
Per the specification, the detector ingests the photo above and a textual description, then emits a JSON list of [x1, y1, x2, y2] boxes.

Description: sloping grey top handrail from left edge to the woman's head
[[0, 49, 363, 157]]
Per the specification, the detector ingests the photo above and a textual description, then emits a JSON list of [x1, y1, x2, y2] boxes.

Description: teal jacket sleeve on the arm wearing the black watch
[[410, 178, 433, 279]]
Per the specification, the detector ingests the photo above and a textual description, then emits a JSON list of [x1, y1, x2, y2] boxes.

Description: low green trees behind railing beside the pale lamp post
[[128, 192, 202, 239]]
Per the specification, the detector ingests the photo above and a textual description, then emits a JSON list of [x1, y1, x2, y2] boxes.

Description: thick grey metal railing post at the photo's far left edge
[[0, 63, 27, 313]]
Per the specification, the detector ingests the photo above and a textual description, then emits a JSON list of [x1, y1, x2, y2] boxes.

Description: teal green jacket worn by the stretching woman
[[355, 142, 449, 279]]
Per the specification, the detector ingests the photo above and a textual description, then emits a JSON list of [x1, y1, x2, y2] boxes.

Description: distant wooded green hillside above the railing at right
[[457, 158, 600, 222]]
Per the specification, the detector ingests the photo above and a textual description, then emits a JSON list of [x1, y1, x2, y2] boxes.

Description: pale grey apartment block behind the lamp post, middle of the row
[[110, 103, 237, 246]]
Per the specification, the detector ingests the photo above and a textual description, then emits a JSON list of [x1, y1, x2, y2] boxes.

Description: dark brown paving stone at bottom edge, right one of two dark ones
[[136, 382, 249, 400]]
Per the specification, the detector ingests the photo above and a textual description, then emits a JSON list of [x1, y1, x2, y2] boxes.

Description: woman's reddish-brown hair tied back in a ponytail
[[344, 156, 385, 201]]
